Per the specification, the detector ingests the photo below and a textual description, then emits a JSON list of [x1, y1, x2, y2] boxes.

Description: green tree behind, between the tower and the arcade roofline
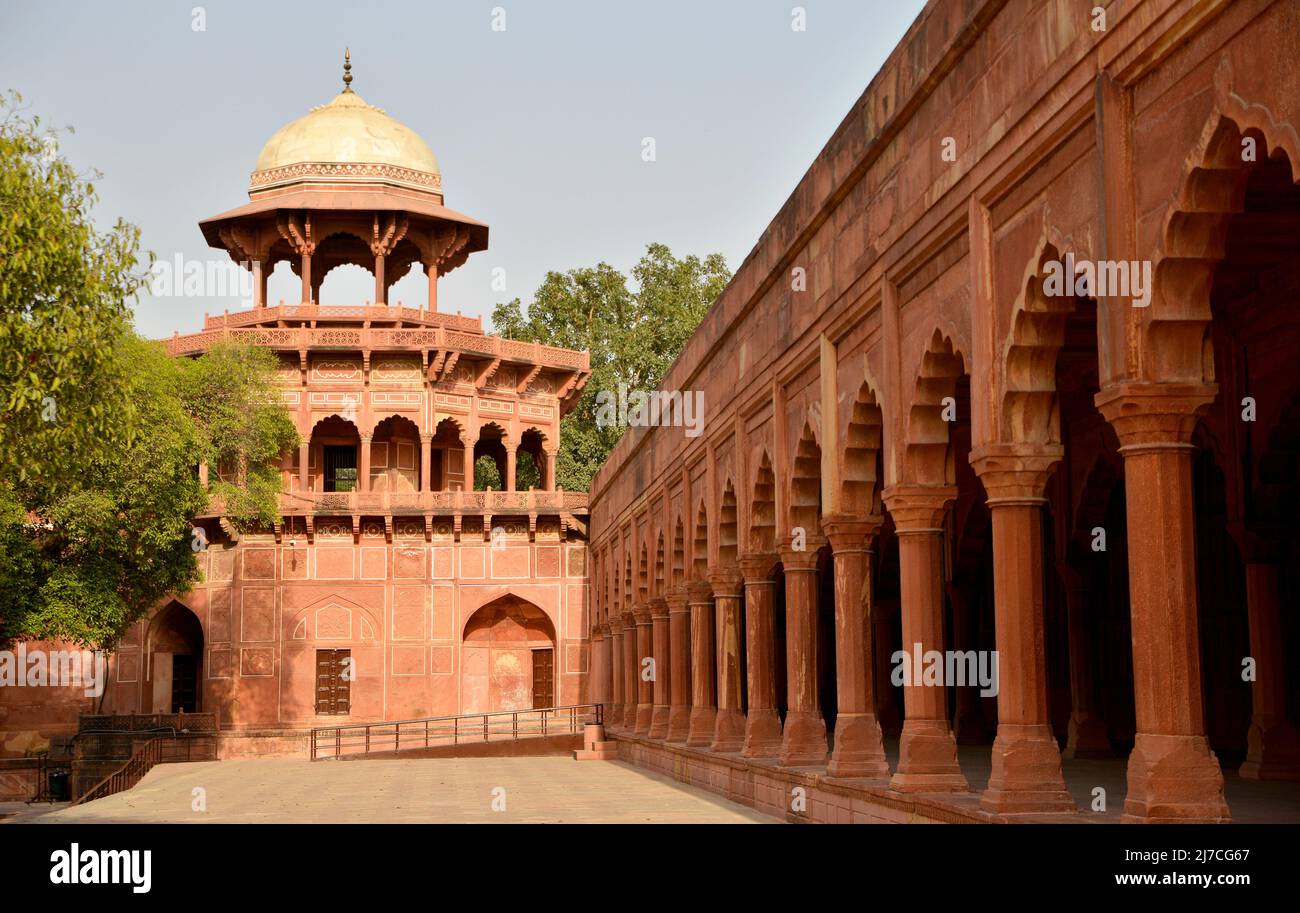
[[493, 245, 731, 492]]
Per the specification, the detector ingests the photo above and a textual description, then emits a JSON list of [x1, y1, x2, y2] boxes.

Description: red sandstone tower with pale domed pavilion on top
[[0, 64, 589, 757]]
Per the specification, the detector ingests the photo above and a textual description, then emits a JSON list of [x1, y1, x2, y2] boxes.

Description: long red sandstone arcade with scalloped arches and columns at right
[[592, 0, 1300, 822]]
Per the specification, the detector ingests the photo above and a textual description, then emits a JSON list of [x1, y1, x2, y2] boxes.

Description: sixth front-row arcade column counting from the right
[[740, 554, 781, 758]]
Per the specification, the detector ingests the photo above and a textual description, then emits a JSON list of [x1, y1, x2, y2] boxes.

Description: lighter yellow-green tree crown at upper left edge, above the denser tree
[[0, 92, 147, 488]]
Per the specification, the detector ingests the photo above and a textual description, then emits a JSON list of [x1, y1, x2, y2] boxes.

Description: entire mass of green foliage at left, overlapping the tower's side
[[0, 96, 296, 649]]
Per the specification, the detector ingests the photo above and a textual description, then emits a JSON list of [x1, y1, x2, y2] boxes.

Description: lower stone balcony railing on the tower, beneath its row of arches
[[193, 489, 588, 516]]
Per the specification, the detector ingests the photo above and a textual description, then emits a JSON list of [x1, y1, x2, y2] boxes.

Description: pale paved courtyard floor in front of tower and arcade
[[10, 757, 775, 825]]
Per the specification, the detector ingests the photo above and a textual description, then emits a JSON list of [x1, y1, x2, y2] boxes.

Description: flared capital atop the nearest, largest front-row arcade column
[[1095, 382, 1218, 453]]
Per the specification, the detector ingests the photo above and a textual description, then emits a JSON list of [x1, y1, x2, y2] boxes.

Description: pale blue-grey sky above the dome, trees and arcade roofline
[[0, 0, 924, 337]]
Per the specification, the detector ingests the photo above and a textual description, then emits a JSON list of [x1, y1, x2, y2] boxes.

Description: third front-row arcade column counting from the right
[[884, 485, 969, 792]]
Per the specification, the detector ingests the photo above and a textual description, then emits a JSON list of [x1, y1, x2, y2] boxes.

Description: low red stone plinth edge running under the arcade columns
[[611, 734, 998, 825]]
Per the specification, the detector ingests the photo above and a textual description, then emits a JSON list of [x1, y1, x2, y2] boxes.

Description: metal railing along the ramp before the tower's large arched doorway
[[311, 704, 605, 761]]
